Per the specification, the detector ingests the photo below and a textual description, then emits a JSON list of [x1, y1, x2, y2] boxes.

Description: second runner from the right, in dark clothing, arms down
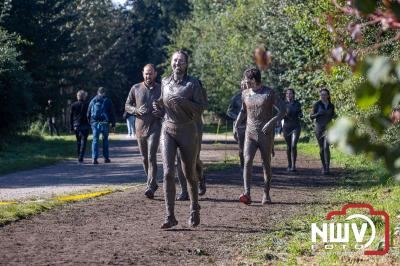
[[283, 89, 303, 172]]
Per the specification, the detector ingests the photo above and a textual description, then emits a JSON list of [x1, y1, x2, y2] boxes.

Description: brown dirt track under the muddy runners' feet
[[0, 136, 338, 265]]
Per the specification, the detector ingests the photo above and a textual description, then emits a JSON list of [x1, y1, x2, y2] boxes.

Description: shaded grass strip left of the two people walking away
[[0, 135, 76, 174]]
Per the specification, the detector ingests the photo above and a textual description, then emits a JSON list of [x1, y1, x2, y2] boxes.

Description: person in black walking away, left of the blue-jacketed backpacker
[[70, 90, 90, 163]]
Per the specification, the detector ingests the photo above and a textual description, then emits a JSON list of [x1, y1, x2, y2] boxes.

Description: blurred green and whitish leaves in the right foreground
[[329, 57, 400, 180]]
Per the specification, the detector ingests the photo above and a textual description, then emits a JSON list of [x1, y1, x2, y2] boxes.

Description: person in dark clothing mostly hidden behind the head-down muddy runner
[[226, 82, 246, 171]]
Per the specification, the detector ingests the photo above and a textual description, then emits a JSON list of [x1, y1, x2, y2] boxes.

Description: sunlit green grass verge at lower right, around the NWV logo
[[245, 142, 400, 265]]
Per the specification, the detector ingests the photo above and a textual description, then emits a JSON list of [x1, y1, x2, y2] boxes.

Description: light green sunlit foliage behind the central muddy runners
[[165, 0, 338, 129]]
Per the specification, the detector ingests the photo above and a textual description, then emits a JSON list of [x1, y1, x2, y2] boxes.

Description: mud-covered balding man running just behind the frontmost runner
[[125, 64, 164, 199]]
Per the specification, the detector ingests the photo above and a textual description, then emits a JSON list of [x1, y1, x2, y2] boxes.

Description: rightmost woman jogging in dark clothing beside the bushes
[[310, 88, 336, 175]]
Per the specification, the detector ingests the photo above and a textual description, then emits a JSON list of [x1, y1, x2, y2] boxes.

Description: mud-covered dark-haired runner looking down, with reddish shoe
[[235, 68, 285, 204]]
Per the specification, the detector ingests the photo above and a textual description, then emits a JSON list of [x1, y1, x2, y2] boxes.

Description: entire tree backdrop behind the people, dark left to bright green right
[[0, 0, 400, 177]]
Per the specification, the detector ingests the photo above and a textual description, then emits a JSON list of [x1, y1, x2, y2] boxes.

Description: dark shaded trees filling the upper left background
[[0, 0, 189, 134]]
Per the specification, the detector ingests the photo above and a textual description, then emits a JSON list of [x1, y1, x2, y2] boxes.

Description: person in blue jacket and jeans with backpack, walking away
[[87, 87, 115, 164]]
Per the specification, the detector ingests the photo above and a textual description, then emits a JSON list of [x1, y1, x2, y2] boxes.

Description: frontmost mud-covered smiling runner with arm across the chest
[[153, 51, 207, 229]]
